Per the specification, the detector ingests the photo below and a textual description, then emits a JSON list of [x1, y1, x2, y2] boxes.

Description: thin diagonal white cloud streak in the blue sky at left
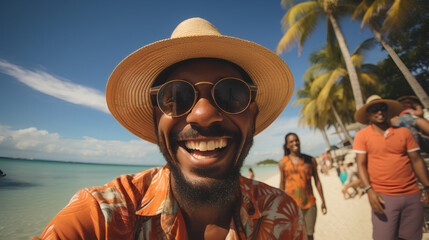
[[0, 59, 109, 113]]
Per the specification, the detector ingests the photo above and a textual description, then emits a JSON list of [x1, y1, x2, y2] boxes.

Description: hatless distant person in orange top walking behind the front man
[[279, 133, 327, 240]]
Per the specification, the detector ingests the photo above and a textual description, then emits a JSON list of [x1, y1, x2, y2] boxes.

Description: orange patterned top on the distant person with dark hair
[[281, 154, 316, 209]]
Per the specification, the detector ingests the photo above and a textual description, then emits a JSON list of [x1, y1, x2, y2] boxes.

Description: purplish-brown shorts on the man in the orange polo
[[372, 194, 423, 240]]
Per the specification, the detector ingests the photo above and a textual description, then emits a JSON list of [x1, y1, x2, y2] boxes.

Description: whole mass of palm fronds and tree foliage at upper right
[[277, 0, 429, 146]]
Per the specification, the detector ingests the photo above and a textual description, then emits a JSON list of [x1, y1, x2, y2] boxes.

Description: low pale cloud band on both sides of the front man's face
[[0, 117, 338, 165]]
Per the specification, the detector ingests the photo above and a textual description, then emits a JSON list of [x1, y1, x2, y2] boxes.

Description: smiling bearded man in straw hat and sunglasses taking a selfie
[[35, 18, 306, 239]]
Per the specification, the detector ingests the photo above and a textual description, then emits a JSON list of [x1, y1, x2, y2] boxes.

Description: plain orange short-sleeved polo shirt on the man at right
[[353, 125, 420, 196]]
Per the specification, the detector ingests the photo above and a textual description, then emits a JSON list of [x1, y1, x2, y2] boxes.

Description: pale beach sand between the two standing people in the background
[[263, 169, 429, 240]]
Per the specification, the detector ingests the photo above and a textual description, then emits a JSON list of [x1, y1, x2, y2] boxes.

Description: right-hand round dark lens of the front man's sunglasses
[[213, 78, 251, 113]]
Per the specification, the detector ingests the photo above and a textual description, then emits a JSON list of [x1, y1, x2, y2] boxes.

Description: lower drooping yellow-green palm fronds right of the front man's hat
[[293, 39, 379, 146]]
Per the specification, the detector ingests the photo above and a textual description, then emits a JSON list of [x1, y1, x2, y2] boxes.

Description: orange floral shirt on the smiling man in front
[[33, 166, 306, 240]]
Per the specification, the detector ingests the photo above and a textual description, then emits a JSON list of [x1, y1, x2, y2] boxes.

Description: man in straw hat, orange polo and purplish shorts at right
[[353, 95, 429, 240]]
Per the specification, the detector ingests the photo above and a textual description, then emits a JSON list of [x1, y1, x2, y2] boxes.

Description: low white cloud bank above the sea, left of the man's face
[[0, 125, 165, 165]]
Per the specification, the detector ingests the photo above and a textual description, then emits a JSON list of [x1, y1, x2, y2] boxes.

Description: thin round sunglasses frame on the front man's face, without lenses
[[150, 77, 258, 117]]
